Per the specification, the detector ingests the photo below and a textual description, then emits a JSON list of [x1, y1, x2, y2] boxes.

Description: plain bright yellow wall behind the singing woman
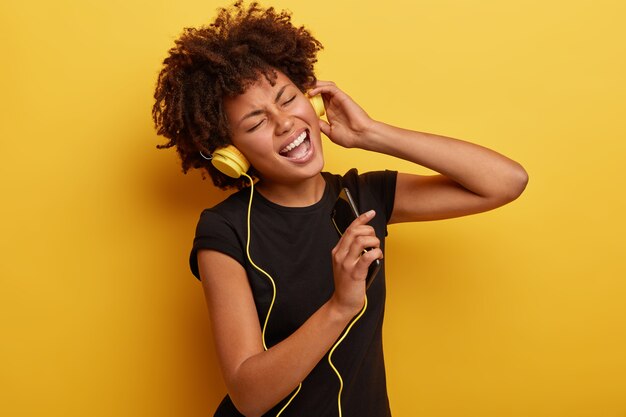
[[0, 0, 626, 417]]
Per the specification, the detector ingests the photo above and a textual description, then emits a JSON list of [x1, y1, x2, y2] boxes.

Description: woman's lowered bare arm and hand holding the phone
[[198, 213, 382, 416]]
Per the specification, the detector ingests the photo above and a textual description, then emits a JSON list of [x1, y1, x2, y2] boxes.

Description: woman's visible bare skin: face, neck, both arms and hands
[[198, 73, 528, 416]]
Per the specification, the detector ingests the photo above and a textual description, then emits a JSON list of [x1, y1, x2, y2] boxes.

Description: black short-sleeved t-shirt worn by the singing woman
[[190, 169, 397, 417]]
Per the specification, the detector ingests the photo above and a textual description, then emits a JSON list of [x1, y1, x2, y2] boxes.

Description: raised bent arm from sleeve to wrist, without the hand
[[365, 123, 528, 223]]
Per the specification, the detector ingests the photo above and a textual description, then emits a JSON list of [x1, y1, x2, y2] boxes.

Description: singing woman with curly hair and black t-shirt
[[153, 2, 527, 416]]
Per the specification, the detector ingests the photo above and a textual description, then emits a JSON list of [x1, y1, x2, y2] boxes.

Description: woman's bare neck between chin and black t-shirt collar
[[255, 173, 326, 207]]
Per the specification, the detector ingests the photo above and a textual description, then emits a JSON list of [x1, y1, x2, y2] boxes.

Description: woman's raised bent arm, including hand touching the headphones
[[309, 81, 528, 223]]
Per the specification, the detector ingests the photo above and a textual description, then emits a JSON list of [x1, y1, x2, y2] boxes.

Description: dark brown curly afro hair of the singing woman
[[152, 0, 322, 189]]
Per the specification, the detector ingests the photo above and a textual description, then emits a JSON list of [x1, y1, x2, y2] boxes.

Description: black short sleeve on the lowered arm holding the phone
[[189, 210, 245, 279]]
